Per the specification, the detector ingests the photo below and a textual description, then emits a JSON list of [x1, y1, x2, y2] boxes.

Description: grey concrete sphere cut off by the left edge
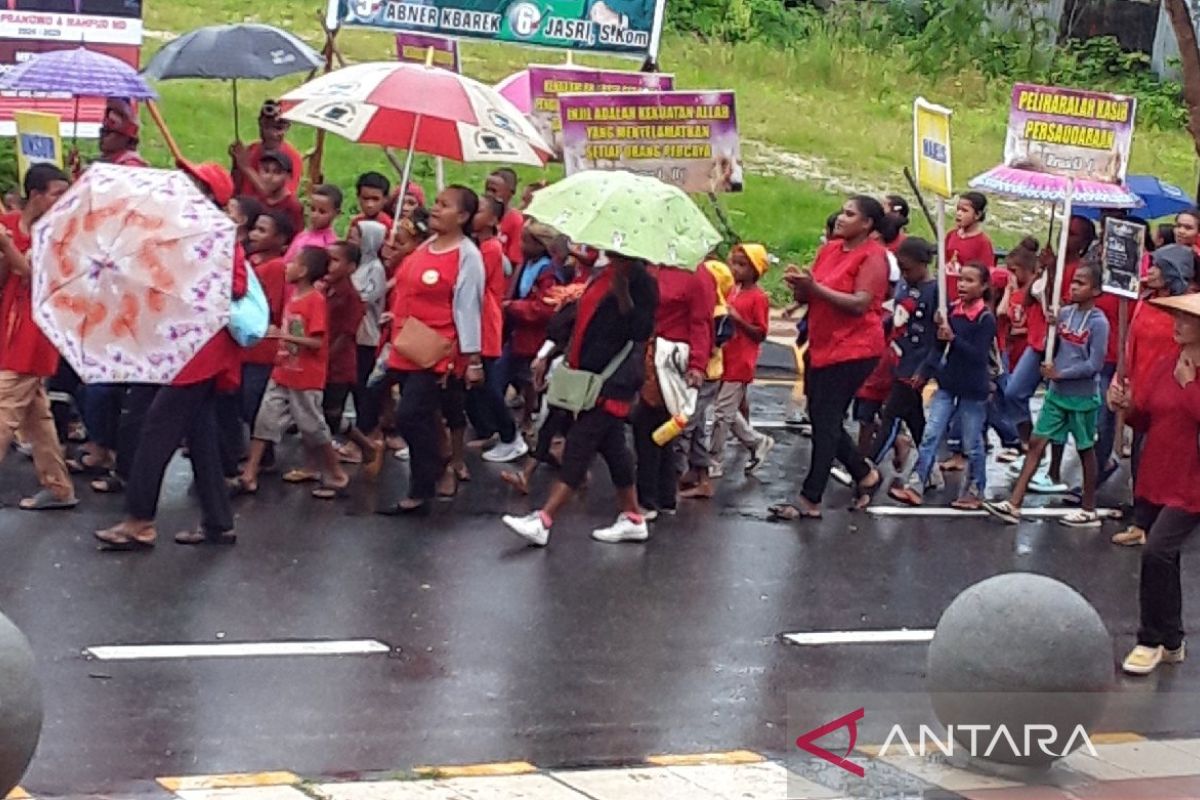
[[0, 614, 42, 798]]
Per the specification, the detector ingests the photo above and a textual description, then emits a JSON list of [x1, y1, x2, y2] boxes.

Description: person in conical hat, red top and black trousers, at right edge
[[1109, 294, 1200, 675]]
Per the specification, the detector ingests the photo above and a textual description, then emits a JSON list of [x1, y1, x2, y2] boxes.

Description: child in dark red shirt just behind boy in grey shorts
[[313, 241, 376, 474]]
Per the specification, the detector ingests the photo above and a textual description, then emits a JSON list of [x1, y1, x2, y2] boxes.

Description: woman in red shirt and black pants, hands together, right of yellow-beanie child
[[770, 194, 888, 521]]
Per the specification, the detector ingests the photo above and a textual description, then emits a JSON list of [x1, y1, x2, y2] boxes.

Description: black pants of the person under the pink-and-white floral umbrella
[[125, 380, 233, 536]]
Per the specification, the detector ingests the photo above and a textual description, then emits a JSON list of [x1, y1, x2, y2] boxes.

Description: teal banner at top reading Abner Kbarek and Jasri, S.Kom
[[325, 0, 666, 56]]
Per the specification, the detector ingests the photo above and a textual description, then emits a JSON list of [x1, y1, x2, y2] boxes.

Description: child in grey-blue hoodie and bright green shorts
[[984, 261, 1109, 528]]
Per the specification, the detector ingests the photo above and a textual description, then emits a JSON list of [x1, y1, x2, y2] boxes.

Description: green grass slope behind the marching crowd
[[133, 0, 1196, 299]]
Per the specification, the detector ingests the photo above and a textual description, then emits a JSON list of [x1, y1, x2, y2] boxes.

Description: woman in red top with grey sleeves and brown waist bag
[[379, 185, 485, 516]]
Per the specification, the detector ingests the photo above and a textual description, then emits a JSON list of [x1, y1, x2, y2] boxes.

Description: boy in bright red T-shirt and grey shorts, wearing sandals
[[240, 247, 350, 499]]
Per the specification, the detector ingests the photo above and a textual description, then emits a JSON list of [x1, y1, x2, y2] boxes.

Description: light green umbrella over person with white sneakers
[[526, 170, 721, 270]]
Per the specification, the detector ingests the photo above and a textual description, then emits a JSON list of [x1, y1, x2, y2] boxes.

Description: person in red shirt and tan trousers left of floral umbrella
[[0, 164, 79, 511]]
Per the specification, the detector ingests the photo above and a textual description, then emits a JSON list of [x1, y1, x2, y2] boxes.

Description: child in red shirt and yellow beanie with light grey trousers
[[709, 245, 775, 475]]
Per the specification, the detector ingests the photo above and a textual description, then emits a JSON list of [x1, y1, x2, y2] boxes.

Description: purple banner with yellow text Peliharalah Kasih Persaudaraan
[[1004, 84, 1138, 184]]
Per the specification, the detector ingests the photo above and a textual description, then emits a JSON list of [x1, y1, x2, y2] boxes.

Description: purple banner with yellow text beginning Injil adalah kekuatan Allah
[[558, 91, 743, 192]]
